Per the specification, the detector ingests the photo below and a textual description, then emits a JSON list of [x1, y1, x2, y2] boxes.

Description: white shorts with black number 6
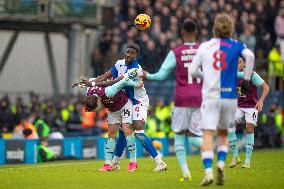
[[235, 108, 258, 126]]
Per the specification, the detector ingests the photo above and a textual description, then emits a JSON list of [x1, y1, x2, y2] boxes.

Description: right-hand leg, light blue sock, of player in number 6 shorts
[[242, 123, 254, 169]]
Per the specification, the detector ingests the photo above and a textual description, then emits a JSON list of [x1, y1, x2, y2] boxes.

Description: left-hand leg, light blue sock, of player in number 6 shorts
[[228, 126, 241, 168]]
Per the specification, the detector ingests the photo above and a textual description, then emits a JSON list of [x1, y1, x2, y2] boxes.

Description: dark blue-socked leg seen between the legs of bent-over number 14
[[112, 130, 127, 170]]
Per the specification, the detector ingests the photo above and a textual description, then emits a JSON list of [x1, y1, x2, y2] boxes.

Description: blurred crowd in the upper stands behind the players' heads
[[91, 0, 284, 90]]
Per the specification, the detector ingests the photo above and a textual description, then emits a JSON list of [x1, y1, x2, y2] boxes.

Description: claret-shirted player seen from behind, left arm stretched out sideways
[[144, 20, 202, 181]]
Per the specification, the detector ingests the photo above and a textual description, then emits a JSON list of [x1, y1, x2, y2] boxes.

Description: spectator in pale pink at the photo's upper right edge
[[274, 7, 284, 62]]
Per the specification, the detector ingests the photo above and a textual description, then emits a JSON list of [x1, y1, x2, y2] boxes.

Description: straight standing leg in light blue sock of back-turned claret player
[[174, 133, 191, 181]]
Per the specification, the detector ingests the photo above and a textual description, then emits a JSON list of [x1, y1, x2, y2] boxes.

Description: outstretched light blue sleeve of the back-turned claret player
[[147, 50, 176, 81]]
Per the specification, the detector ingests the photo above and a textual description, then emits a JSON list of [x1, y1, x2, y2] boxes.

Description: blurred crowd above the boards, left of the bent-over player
[[0, 93, 107, 139]]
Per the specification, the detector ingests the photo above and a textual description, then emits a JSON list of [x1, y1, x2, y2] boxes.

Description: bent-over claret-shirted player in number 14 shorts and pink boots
[[73, 78, 143, 171]]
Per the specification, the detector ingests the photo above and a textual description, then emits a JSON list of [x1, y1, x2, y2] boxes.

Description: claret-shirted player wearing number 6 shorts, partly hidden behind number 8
[[228, 58, 269, 168]]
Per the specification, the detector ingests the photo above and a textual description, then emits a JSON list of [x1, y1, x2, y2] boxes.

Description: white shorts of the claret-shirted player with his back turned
[[172, 107, 202, 136]]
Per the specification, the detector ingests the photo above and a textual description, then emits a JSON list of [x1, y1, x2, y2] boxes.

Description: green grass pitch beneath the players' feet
[[0, 150, 284, 189]]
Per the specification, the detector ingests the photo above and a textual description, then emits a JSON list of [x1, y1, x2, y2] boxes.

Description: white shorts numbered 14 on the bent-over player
[[108, 100, 133, 124]]
